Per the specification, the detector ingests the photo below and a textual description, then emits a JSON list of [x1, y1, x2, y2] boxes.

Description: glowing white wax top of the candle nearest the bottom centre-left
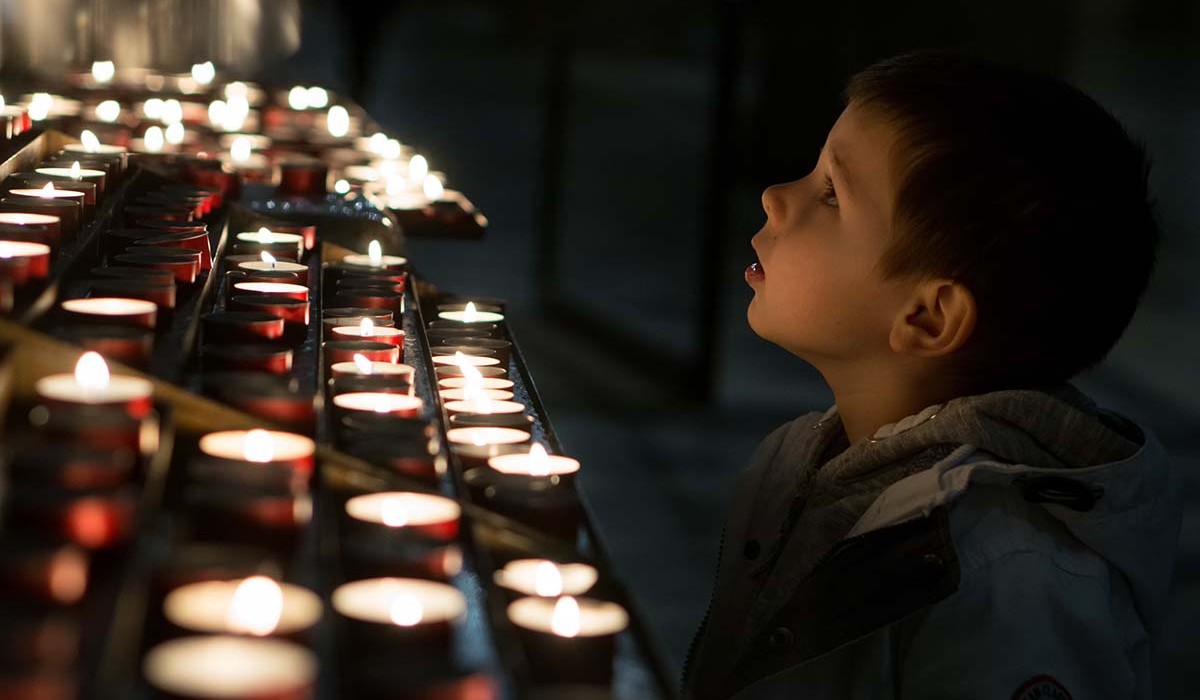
[[332, 578, 467, 627]]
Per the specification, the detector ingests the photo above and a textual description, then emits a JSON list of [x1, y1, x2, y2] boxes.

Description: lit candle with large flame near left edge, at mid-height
[[35, 352, 154, 418]]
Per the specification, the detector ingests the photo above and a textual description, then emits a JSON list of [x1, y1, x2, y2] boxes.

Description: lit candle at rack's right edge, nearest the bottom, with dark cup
[[508, 596, 629, 683]]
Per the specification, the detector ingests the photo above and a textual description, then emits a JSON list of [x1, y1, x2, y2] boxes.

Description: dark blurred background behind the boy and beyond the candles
[[0, 0, 1200, 698]]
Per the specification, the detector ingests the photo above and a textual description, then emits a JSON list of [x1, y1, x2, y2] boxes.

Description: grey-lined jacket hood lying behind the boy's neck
[[844, 384, 1181, 630]]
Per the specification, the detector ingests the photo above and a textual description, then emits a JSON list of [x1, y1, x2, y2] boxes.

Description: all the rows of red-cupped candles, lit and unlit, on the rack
[[0, 64, 628, 698]]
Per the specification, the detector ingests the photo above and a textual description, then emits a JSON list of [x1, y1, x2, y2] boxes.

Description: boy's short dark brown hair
[[846, 52, 1158, 391]]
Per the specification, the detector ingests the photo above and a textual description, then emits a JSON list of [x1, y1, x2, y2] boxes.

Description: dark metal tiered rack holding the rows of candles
[[0, 126, 674, 699]]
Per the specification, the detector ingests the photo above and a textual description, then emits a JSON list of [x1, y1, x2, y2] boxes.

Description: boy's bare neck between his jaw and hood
[[823, 372, 960, 444]]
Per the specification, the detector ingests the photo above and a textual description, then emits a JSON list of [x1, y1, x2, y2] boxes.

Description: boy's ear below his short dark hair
[[888, 280, 977, 358]]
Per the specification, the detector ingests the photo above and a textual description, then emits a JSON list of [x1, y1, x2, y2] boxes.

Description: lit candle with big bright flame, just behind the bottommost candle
[[162, 576, 322, 636]]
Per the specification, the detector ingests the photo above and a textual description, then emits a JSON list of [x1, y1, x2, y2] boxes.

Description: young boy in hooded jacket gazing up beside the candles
[[684, 53, 1180, 700]]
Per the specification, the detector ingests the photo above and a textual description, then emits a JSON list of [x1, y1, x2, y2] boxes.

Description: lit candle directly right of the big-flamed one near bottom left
[[332, 578, 467, 650]]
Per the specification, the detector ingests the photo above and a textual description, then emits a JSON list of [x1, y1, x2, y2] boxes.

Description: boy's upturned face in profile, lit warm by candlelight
[[746, 104, 911, 370]]
